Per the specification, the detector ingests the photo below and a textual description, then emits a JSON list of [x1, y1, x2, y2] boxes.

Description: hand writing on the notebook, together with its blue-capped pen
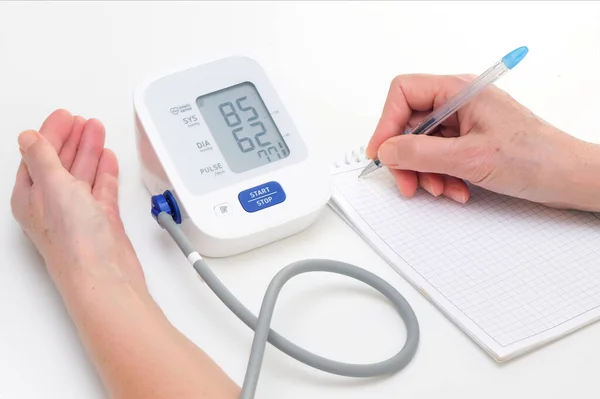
[[362, 47, 590, 209]]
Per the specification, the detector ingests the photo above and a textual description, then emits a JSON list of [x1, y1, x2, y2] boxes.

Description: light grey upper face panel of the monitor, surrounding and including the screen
[[139, 58, 308, 199]]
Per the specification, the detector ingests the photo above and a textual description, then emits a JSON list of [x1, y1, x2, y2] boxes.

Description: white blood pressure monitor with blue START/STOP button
[[134, 57, 330, 257]]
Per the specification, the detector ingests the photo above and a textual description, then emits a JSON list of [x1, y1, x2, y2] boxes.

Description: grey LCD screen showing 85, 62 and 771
[[196, 82, 290, 173]]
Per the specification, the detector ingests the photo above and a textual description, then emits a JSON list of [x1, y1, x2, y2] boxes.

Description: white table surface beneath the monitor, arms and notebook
[[0, 2, 600, 399]]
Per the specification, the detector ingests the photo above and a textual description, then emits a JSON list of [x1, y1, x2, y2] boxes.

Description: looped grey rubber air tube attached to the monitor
[[157, 212, 419, 399]]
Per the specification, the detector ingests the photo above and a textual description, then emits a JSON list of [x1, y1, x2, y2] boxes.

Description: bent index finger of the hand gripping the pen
[[367, 75, 474, 158]]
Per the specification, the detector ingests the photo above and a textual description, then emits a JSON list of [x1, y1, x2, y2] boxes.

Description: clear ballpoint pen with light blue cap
[[358, 46, 529, 177]]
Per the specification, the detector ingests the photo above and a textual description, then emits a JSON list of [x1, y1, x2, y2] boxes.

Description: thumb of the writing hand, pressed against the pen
[[377, 134, 477, 180]]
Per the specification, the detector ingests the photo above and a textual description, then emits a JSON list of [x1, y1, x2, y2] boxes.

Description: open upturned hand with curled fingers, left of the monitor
[[11, 110, 144, 292]]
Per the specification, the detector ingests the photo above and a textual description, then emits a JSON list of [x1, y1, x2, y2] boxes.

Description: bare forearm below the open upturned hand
[[52, 262, 239, 399]]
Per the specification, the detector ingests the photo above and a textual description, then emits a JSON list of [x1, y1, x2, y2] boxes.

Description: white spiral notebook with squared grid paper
[[330, 148, 600, 362]]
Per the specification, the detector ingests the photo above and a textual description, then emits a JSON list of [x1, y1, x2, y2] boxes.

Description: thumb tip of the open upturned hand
[[19, 130, 63, 183]]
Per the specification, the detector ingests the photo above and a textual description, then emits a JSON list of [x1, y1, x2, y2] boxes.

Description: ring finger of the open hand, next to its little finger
[[71, 119, 105, 187]]
